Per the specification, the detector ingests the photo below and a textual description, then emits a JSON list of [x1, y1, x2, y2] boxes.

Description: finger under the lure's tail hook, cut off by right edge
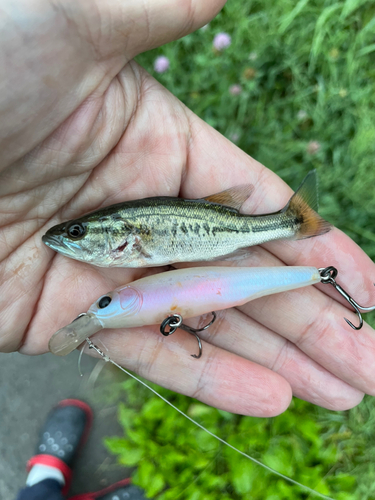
[[239, 276, 375, 395]]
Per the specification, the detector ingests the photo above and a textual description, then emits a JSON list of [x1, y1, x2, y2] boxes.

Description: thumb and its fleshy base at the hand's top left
[[0, 0, 225, 170]]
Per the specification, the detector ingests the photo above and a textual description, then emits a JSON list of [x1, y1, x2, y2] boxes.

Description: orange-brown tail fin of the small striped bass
[[283, 170, 332, 240]]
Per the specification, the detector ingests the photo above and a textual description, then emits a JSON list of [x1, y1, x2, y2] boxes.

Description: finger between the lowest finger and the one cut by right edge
[[187, 309, 363, 411]]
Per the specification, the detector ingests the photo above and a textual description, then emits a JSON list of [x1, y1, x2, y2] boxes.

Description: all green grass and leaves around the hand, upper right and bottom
[[107, 0, 375, 500]]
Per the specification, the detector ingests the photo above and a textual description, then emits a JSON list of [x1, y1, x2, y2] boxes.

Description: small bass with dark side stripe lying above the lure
[[43, 171, 331, 267]]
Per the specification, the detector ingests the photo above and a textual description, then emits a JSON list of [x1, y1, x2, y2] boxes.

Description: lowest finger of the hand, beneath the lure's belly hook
[[85, 327, 291, 417]]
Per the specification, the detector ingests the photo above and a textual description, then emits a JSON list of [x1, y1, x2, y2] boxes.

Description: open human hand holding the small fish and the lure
[[0, 0, 375, 416]]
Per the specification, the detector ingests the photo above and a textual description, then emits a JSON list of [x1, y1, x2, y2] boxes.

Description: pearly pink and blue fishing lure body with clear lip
[[49, 266, 321, 356]]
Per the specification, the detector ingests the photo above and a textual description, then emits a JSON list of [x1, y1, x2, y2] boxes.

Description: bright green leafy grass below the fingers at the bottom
[[106, 380, 375, 500]]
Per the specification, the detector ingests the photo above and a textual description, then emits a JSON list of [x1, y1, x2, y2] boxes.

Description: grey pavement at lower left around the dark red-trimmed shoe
[[0, 352, 129, 500]]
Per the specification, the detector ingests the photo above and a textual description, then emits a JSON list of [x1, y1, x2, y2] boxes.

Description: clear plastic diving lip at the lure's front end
[[48, 313, 103, 356]]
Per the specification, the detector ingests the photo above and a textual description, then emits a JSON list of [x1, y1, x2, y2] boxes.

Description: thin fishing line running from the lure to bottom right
[[86, 338, 334, 500]]
